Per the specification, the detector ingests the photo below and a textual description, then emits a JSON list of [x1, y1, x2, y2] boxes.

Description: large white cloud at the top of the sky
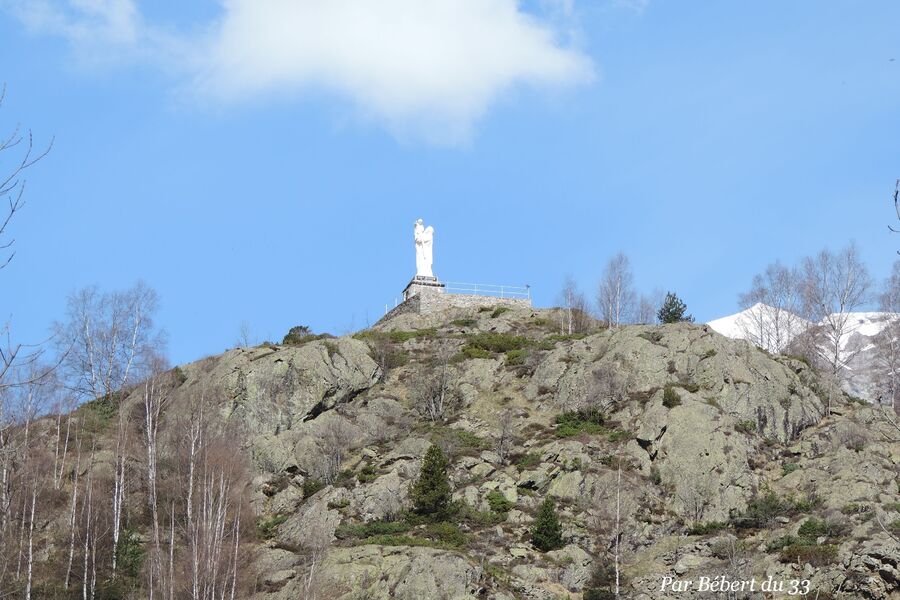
[[7, 0, 593, 141]]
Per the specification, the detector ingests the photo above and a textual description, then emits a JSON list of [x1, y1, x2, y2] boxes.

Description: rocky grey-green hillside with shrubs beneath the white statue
[[15, 308, 900, 600]]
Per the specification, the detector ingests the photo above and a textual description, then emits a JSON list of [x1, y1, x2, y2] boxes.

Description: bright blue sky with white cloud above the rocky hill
[[0, 0, 900, 362]]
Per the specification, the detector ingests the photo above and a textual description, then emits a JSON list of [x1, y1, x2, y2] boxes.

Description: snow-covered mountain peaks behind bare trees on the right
[[707, 304, 900, 402]]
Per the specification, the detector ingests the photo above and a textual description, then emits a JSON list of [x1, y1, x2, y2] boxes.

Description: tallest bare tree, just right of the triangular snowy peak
[[801, 244, 872, 390]]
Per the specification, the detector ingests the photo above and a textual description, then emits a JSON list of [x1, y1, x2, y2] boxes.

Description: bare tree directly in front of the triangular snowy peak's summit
[[738, 261, 805, 352]]
